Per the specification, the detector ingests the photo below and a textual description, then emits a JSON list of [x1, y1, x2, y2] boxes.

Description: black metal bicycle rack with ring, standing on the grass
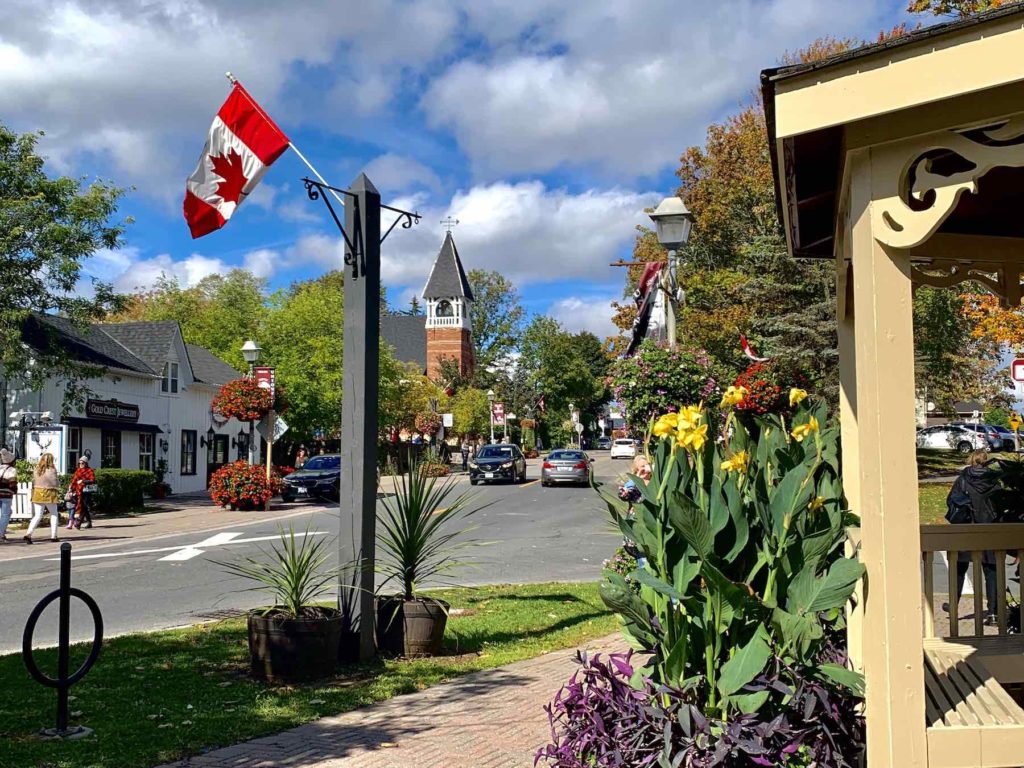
[[22, 544, 103, 738]]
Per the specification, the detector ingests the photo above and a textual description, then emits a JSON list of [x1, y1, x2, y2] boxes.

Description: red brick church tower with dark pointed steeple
[[423, 230, 474, 380]]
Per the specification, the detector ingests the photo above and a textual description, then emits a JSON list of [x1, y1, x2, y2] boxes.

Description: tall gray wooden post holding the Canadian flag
[[338, 173, 381, 660]]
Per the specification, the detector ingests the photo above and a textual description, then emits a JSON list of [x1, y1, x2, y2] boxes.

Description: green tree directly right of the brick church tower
[[467, 269, 525, 386]]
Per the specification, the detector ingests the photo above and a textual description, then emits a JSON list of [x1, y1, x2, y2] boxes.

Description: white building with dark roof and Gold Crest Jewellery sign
[[0, 315, 248, 493]]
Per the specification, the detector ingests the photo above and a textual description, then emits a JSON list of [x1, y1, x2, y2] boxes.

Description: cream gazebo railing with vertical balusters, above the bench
[[921, 523, 1024, 638]]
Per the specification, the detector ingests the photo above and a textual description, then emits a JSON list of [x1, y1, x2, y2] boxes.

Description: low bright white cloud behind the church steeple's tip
[[381, 181, 660, 288]]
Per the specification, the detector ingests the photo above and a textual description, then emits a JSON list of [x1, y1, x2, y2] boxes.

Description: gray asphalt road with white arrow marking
[[0, 455, 628, 653]]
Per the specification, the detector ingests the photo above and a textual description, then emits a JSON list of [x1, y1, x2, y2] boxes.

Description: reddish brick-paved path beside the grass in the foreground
[[163, 634, 626, 768]]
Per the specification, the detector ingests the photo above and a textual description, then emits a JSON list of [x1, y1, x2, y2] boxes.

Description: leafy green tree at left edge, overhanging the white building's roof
[[0, 124, 124, 408]]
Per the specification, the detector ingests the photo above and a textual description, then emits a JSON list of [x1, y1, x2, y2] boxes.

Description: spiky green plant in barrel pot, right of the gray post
[[377, 465, 483, 657]]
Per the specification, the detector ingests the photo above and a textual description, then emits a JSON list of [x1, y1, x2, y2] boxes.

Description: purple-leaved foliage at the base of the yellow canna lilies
[[536, 651, 864, 768]]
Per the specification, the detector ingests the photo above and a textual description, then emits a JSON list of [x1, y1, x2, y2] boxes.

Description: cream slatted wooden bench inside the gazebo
[[925, 638, 1024, 768]]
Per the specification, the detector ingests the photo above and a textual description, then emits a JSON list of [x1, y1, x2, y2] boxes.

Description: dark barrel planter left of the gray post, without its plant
[[249, 608, 342, 683]]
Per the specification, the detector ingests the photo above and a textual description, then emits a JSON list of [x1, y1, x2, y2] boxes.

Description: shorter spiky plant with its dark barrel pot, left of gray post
[[217, 526, 342, 683]]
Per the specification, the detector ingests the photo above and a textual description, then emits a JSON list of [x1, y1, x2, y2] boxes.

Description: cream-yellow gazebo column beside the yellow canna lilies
[[843, 150, 928, 768]]
